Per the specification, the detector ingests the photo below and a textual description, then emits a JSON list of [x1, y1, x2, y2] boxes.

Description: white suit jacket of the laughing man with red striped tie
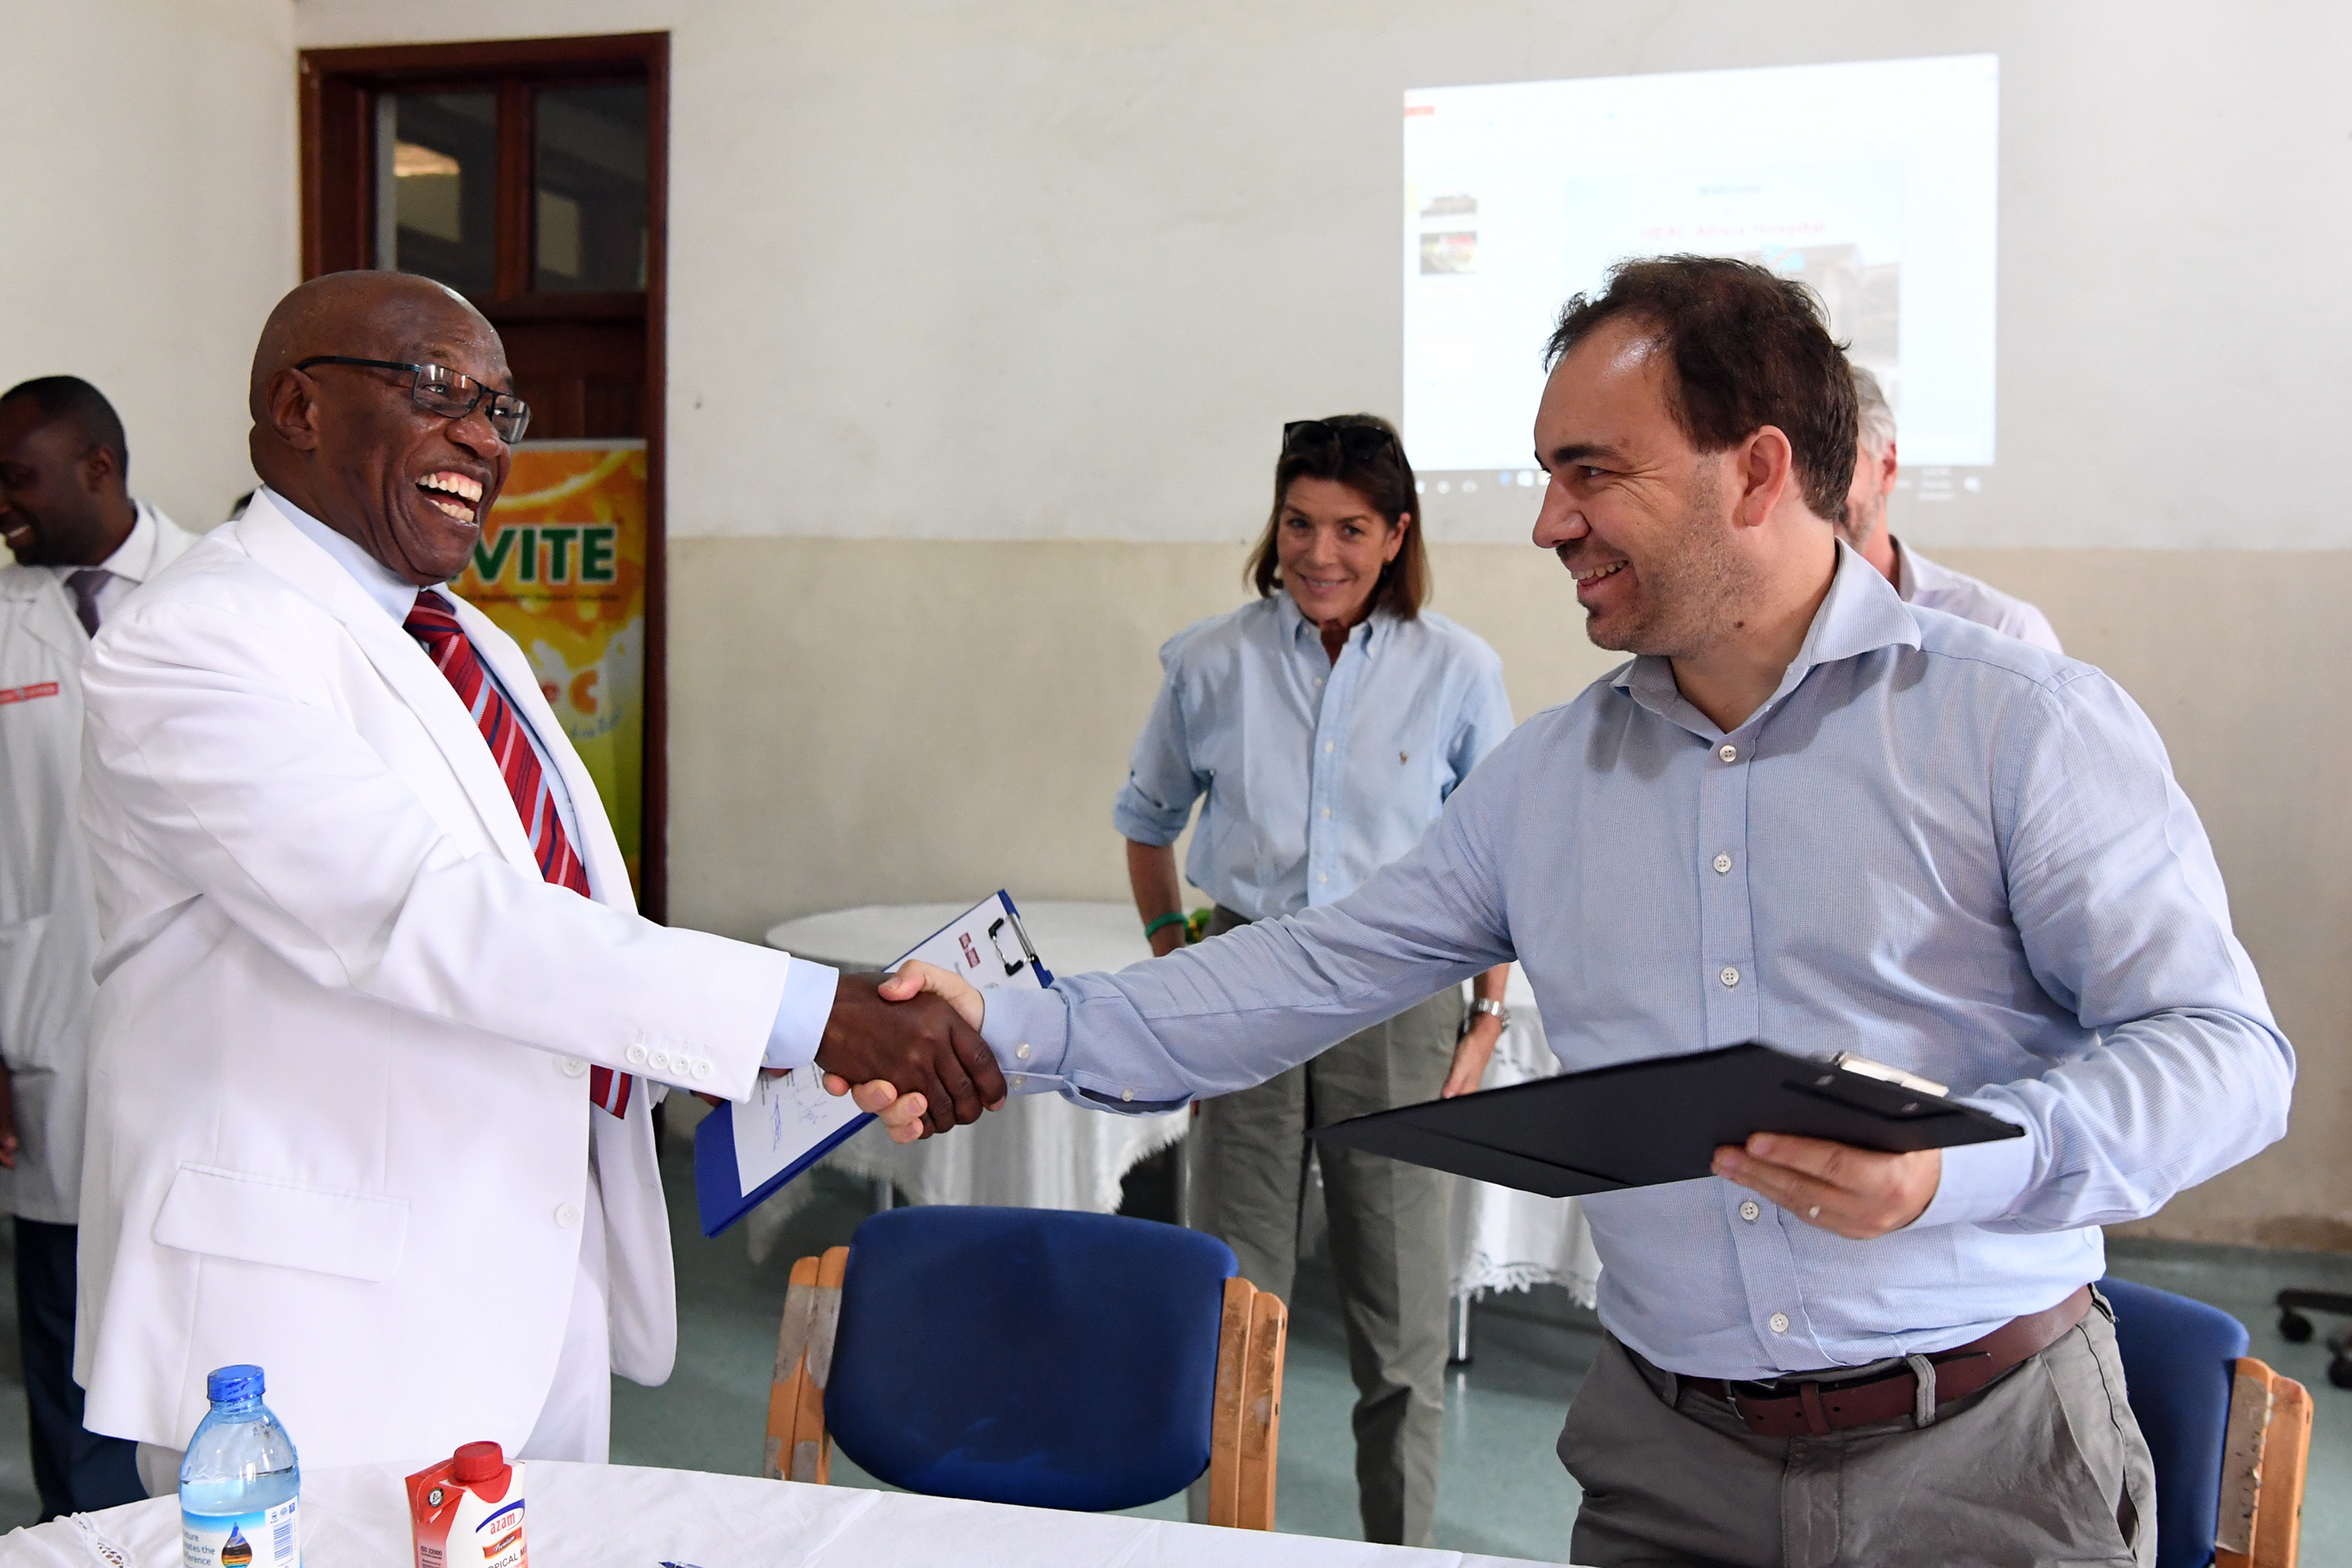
[[75, 491, 790, 1469]]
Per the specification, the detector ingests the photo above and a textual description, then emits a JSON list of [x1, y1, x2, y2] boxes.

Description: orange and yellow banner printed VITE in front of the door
[[454, 440, 644, 884]]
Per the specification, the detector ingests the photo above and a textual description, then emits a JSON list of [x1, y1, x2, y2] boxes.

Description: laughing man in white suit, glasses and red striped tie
[[77, 272, 983, 1491]]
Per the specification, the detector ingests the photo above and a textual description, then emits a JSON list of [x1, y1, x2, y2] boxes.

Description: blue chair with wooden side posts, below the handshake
[[767, 1206, 1286, 1528]]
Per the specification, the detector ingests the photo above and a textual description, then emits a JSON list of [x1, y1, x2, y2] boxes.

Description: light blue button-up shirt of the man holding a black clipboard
[[983, 548, 2293, 1378]]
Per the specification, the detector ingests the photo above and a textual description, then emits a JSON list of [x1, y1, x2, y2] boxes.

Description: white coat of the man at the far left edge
[[0, 503, 195, 1225]]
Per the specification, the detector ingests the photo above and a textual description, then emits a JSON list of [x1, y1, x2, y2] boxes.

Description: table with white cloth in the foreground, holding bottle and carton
[[0, 1460, 1571, 1568]]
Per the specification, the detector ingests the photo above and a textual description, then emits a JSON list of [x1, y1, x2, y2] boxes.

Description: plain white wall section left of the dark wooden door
[[0, 0, 296, 529]]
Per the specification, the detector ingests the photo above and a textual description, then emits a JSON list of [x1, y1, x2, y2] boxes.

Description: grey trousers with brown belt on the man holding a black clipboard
[[1560, 1302, 2157, 1568]]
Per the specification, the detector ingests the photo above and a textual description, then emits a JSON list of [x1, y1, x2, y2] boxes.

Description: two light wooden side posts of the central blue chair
[[760, 1246, 1289, 1531]]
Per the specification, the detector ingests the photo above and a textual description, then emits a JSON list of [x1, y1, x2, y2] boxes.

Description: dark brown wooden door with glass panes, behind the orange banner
[[301, 33, 671, 919]]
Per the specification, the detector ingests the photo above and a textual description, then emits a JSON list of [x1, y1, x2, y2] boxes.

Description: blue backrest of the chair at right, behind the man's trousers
[[2098, 1279, 2248, 1568]]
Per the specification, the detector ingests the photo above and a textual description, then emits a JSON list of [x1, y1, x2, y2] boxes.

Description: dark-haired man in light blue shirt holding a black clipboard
[[902, 259, 2293, 1568]]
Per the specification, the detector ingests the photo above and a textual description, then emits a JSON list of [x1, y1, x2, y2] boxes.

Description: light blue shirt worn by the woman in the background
[[1110, 592, 1510, 919]]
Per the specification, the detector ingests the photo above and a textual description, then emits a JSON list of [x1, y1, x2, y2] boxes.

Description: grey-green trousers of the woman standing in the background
[[1192, 909, 1463, 1546]]
